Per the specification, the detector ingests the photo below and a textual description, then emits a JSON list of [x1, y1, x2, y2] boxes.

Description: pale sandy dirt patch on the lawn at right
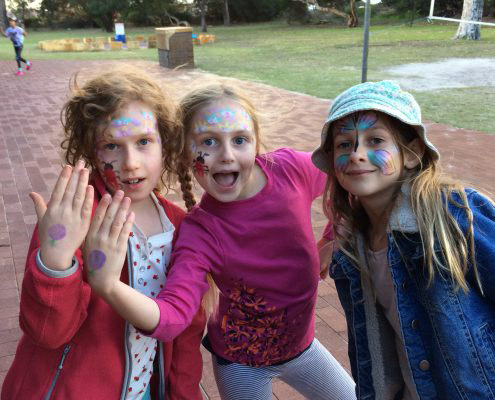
[[385, 58, 495, 91]]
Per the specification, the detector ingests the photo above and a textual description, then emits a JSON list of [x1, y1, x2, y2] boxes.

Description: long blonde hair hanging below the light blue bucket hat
[[323, 113, 488, 292]]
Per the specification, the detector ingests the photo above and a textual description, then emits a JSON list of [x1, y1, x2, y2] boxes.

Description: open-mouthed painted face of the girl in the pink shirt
[[188, 99, 256, 202]]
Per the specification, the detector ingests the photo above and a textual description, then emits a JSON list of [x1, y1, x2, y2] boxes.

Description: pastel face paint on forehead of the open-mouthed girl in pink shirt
[[193, 107, 252, 134]]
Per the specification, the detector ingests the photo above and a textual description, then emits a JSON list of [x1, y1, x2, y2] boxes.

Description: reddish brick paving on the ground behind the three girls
[[0, 61, 495, 400]]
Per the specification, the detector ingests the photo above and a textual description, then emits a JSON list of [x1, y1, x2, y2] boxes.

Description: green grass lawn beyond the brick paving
[[0, 22, 495, 133]]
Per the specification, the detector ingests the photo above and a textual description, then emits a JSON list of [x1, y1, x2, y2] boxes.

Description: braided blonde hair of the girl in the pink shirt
[[177, 83, 263, 314]]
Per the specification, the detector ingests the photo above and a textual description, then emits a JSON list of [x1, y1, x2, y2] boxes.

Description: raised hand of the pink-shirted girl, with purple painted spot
[[84, 190, 134, 295]]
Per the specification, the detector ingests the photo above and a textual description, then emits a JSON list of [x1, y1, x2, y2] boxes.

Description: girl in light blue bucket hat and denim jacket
[[312, 81, 495, 400]]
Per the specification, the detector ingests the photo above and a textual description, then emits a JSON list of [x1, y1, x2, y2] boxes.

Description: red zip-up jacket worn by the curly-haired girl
[[1, 175, 206, 400]]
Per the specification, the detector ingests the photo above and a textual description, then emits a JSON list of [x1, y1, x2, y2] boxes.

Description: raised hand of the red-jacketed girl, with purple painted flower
[[29, 160, 94, 271]]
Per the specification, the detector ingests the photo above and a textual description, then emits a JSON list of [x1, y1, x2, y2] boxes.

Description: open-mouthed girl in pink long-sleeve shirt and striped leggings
[[87, 85, 355, 400]]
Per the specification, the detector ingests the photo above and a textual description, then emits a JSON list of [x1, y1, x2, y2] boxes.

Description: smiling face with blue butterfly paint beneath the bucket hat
[[333, 111, 401, 202]]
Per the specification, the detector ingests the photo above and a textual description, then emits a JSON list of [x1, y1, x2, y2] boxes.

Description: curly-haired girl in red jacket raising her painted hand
[[1, 68, 206, 400]]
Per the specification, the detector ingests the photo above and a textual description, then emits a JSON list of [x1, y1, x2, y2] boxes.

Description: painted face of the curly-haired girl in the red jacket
[[96, 102, 162, 205]]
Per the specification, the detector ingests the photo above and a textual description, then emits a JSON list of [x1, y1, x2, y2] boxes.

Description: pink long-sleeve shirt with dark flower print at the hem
[[152, 149, 326, 366]]
